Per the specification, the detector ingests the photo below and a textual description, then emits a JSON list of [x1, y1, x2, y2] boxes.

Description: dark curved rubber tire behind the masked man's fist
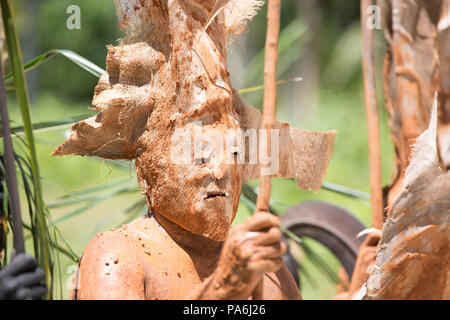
[[281, 201, 366, 283]]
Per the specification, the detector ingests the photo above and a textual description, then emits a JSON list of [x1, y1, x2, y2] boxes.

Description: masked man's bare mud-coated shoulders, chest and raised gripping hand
[[72, 214, 300, 300]]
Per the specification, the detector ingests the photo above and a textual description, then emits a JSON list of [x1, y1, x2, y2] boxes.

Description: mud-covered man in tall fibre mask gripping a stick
[[54, 0, 335, 299]]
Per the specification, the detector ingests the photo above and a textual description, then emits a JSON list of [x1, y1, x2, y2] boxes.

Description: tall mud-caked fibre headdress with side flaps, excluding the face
[[53, 0, 335, 190]]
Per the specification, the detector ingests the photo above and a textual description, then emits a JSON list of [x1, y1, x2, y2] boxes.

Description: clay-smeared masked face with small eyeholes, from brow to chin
[[137, 89, 243, 241]]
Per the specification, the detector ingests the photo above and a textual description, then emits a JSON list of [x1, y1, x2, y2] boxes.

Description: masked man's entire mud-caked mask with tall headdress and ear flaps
[[54, 0, 335, 240]]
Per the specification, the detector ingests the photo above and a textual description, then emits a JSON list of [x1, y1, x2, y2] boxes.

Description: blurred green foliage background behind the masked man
[[5, 0, 393, 299]]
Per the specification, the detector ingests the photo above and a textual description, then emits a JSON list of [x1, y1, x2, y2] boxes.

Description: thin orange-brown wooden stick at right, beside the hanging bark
[[361, 0, 384, 229]]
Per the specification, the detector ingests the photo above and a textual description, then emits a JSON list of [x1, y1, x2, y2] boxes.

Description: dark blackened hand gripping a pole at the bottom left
[[0, 254, 47, 300]]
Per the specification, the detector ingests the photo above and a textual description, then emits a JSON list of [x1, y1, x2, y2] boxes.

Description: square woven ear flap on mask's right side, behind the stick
[[235, 96, 336, 191]]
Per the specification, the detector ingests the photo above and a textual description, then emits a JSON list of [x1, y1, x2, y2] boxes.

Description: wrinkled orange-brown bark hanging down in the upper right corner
[[379, 0, 450, 205]]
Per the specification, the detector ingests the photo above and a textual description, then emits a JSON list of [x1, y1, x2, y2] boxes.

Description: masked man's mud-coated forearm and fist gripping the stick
[[187, 213, 286, 300]]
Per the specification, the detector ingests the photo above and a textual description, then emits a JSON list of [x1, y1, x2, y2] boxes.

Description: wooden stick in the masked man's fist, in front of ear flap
[[252, 0, 281, 300]]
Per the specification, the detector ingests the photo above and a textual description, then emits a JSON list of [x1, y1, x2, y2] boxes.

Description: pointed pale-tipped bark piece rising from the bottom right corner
[[365, 99, 450, 299]]
